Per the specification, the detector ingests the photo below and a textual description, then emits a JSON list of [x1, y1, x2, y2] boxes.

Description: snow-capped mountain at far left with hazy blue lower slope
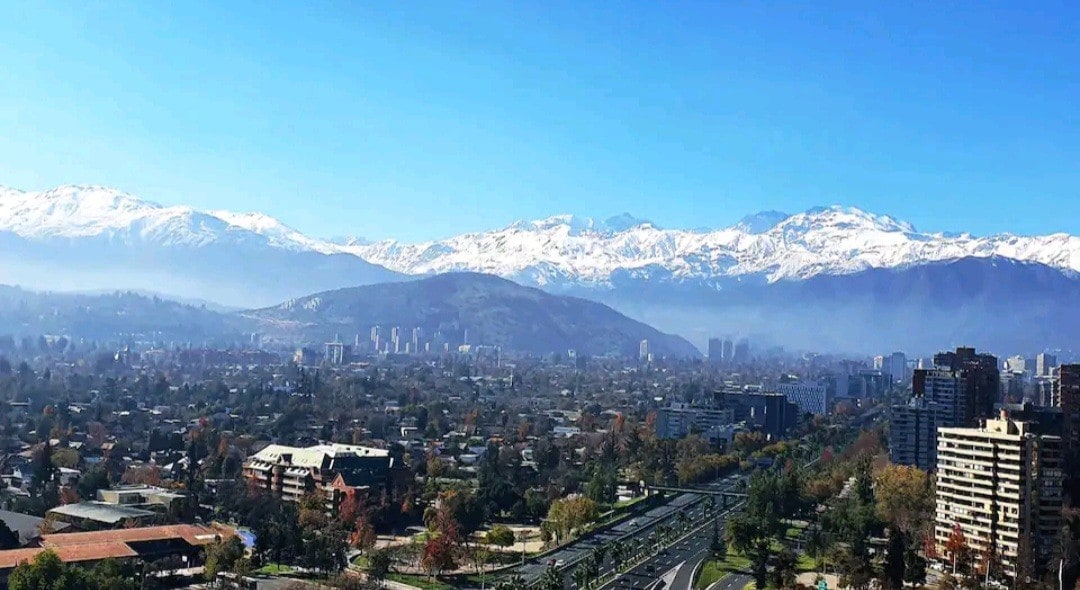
[[0, 186, 401, 307]]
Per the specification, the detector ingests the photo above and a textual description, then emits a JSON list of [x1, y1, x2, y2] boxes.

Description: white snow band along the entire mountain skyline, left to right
[[0, 185, 1080, 286]]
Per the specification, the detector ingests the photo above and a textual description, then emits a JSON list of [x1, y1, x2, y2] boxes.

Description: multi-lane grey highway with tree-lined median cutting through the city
[[517, 474, 743, 590]]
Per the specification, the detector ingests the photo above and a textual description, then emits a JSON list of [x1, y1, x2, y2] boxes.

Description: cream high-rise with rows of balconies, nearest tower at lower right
[[934, 414, 1063, 580]]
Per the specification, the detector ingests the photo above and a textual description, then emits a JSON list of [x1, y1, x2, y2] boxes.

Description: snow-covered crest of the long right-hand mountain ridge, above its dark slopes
[[346, 206, 1080, 287]]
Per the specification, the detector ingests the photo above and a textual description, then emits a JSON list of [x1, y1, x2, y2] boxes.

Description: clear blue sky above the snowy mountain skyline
[[0, 1, 1080, 240]]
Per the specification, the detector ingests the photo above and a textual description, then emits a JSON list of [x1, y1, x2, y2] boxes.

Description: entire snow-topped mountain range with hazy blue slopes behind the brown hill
[[0, 186, 1080, 350]]
